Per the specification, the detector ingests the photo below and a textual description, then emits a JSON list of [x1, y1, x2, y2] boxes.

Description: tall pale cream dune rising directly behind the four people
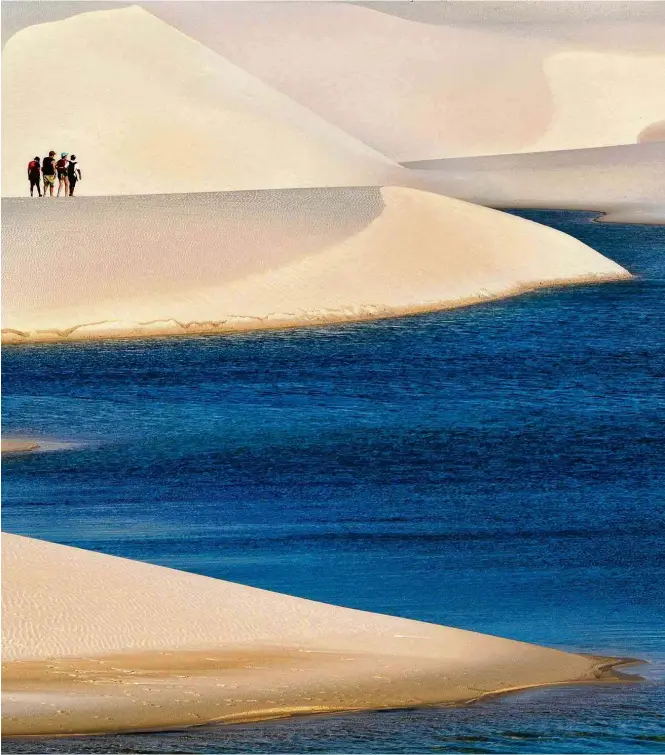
[[2, 7, 400, 196]]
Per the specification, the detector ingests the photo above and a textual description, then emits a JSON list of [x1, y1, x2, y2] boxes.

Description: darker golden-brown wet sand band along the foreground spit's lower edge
[[3, 648, 646, 740]]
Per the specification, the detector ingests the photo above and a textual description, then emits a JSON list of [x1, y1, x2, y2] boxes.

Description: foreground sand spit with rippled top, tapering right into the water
[[2, 534, 640, 736]]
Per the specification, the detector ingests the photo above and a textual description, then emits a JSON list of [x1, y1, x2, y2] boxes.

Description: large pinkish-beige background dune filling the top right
[[146, 2, 665, 162]]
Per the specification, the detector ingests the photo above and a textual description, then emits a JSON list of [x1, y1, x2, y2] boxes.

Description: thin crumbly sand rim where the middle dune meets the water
[[2, 270, 635, 346]]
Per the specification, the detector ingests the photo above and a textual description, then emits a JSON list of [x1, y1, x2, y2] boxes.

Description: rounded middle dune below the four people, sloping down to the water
[[3, 187, 630, 342]]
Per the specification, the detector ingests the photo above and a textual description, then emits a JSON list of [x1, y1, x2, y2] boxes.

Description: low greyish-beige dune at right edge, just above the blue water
[[407, 142, 665, 223]]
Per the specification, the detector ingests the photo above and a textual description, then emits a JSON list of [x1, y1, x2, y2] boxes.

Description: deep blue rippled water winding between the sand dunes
[[3, 211, 665, 753]]
